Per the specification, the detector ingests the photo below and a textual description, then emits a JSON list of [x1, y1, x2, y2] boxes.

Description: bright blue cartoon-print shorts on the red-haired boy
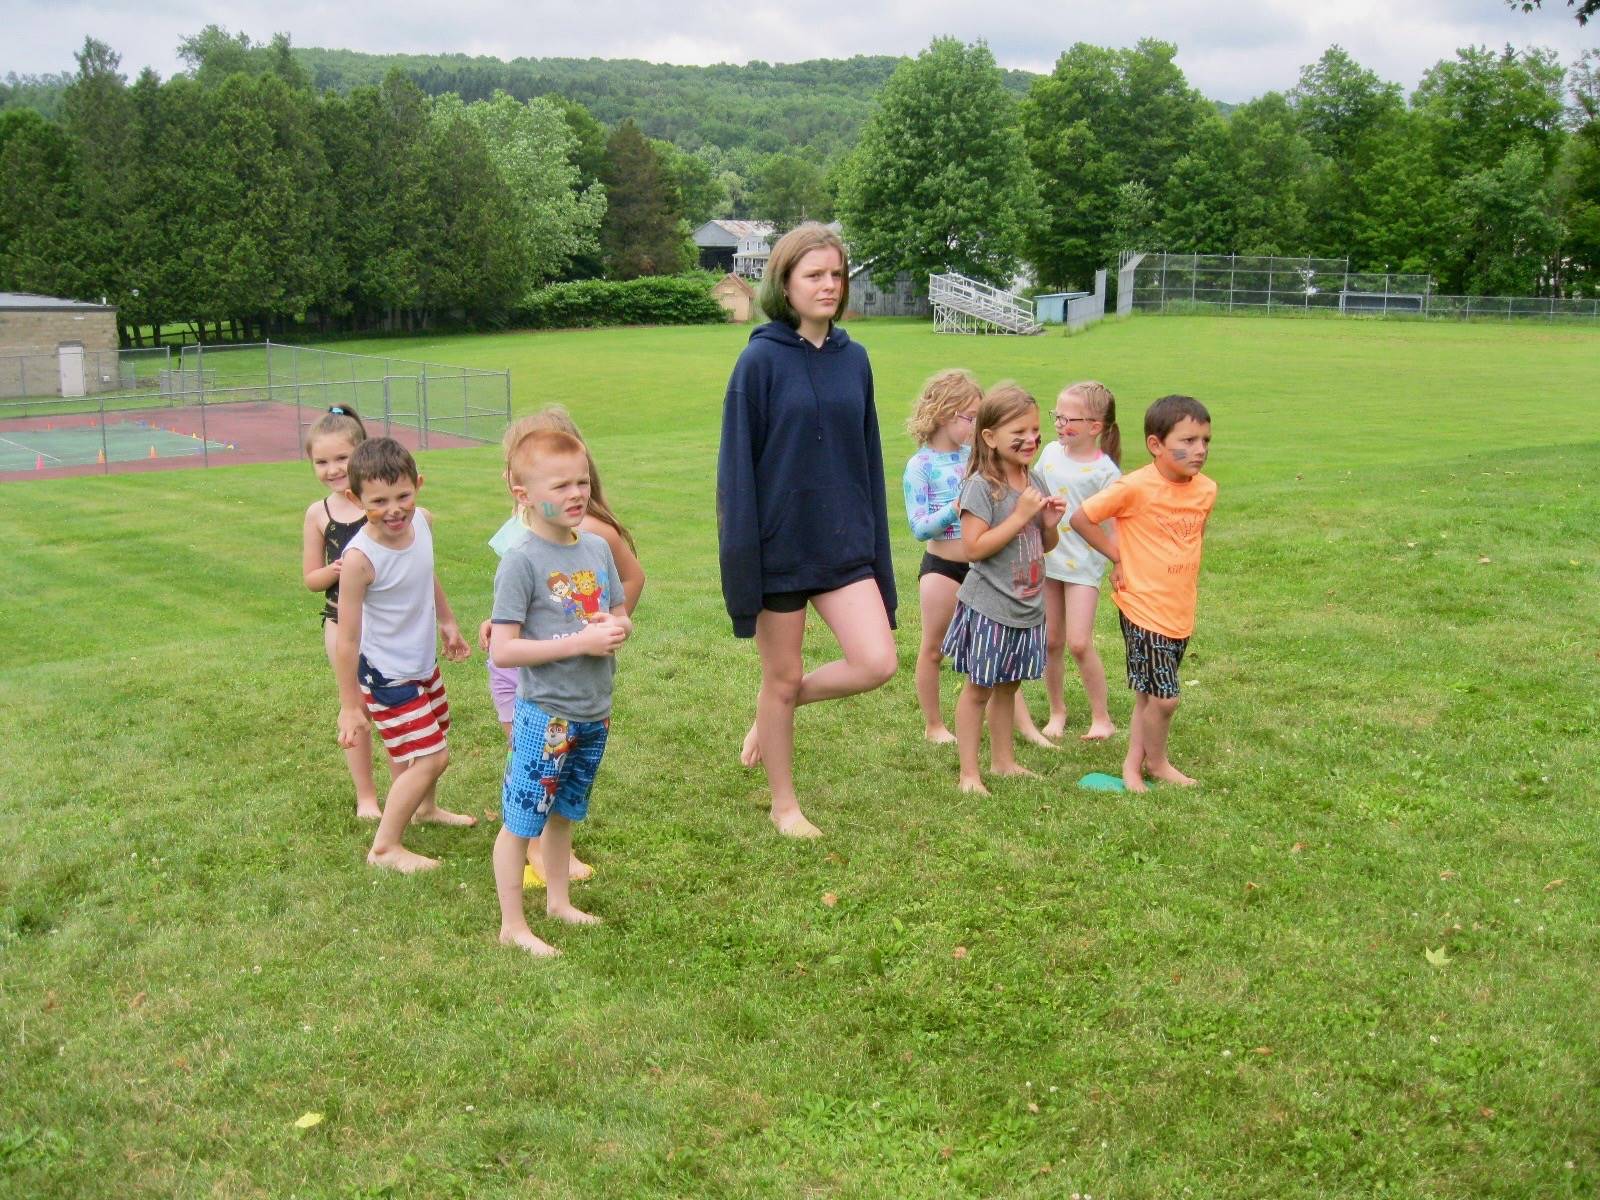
[[501, 696, 611, 837]]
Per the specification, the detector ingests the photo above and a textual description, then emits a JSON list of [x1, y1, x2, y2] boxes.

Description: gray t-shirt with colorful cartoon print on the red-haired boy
[[490, 530, 622, 722]]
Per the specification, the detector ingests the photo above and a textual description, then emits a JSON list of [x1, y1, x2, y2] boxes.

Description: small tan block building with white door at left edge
[[0, 291, 118, 395]]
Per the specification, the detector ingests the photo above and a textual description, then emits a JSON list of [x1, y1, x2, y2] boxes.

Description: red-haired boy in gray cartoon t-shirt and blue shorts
[[490, 426, 634, 955]]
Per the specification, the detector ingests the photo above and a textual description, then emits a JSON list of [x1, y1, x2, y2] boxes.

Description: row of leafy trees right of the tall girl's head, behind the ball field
[[838, 38, 1600, 296]]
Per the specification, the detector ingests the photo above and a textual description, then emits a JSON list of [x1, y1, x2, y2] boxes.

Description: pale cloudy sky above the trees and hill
[[0, 0, 1600, 101]]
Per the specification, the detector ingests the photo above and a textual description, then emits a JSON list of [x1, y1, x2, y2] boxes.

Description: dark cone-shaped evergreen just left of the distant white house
[[600, 120, 690, 278]]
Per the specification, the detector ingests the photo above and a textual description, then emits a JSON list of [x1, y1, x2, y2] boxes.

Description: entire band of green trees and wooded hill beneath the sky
[[0, 26, 1600, 342]]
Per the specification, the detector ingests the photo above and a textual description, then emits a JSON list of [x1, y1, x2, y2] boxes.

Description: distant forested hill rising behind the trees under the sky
[[293, 48, 1034, 162]]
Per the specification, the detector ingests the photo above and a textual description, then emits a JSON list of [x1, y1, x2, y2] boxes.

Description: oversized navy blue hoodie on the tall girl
[[717, 322, 894, 637]]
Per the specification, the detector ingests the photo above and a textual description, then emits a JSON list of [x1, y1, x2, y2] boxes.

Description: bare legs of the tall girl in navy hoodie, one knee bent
[[746, 579, 896, 837]]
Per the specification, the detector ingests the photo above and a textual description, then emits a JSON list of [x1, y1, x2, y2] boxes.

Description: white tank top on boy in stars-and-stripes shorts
[[349, 512, 438, 680]]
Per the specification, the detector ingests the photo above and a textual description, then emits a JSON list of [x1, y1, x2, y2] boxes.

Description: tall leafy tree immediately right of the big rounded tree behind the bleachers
[[1022, 38, 1210, 286]]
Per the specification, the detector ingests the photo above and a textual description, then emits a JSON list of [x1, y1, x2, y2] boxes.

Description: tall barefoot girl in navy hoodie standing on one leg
[[717, 222, 896, 837]]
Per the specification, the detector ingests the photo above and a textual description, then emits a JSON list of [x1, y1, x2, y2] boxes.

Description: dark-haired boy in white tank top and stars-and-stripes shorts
[[333, 437, 477, 874]]
